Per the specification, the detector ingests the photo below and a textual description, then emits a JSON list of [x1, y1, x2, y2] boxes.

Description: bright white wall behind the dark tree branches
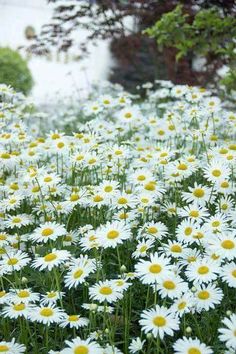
[[0, 0, 112, 102]]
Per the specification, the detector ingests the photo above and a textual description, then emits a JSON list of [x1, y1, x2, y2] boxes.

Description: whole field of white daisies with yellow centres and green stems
[[0, 82, 236, 354]]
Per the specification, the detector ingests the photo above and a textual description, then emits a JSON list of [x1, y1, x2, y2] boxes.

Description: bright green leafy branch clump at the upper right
[[144, 5, 236, 95]]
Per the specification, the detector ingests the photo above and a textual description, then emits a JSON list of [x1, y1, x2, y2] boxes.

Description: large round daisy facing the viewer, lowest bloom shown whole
[[139, 305, 179, 339]]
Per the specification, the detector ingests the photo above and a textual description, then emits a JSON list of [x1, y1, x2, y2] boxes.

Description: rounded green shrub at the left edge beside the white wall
[[0, 48, 33, 94]]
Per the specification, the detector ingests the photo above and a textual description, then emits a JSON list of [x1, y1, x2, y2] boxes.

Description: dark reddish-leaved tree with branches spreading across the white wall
[[29, 0, 236, 90]]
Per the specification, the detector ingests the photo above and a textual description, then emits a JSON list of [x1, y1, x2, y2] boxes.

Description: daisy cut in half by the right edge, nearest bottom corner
[[219, 314, 236, 350]]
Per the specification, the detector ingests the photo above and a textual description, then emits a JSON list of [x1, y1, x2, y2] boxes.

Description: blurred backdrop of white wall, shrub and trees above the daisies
[[0, 0, 236, 102]]
